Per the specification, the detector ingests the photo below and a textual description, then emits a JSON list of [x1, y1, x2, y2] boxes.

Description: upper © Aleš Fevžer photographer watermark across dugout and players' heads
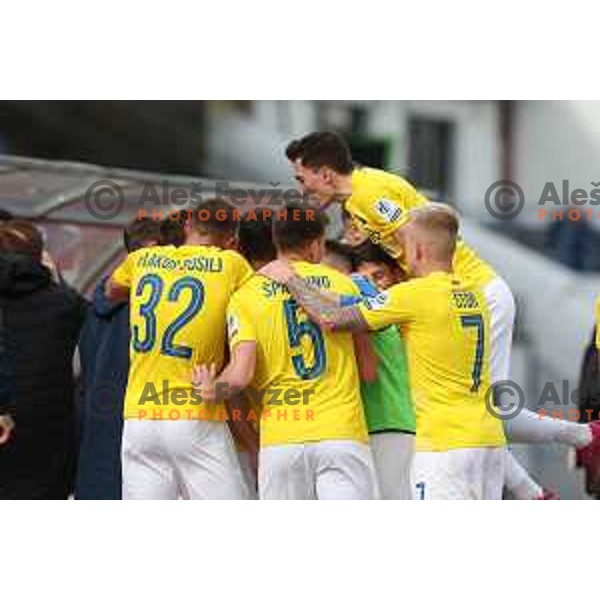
[[83, 179, 310, 221]]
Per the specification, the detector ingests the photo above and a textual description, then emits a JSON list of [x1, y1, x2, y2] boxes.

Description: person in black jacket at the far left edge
[[0, 220, 85, 499]]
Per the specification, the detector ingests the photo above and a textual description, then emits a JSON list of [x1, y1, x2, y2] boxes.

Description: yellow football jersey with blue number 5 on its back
[[227, 262, 368, 446]]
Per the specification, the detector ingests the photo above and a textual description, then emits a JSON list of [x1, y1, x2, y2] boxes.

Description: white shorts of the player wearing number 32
[[122, 420, 248, 500]]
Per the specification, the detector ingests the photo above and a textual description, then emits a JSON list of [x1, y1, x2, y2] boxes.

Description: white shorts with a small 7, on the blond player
[[415, 447, 506, 500]]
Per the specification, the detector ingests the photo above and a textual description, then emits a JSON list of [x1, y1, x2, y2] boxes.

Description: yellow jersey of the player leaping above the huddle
[[344, 167, 496, 286]]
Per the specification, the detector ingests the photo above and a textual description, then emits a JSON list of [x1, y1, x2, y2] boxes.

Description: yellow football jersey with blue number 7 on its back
[[360, 272, 505, 452]]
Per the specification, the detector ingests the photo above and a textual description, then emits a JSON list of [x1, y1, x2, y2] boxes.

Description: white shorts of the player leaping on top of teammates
[[483, 276, 516, 383]]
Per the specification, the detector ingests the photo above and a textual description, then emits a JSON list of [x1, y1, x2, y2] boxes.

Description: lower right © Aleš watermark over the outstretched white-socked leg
[[484, 379, 600, 422]]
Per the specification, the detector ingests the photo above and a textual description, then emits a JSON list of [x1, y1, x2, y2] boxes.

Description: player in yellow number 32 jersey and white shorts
[[107, 200, 252, 500]]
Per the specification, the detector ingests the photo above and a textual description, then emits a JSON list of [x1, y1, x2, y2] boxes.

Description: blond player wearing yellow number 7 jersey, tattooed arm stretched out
[[263, 204, 505, 499]]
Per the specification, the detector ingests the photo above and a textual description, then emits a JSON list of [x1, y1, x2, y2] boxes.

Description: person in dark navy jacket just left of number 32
[[75, 219, 166, 500]]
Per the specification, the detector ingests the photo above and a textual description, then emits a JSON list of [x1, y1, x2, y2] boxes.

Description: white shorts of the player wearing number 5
[[258, 440, 378, 500]]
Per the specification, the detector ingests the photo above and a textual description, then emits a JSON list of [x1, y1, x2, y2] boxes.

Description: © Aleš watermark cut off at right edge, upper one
[[485, 179, 600, 221]]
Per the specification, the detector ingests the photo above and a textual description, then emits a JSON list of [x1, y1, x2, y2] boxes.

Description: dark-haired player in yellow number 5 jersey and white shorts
[[194, 207, 377, 500]]
